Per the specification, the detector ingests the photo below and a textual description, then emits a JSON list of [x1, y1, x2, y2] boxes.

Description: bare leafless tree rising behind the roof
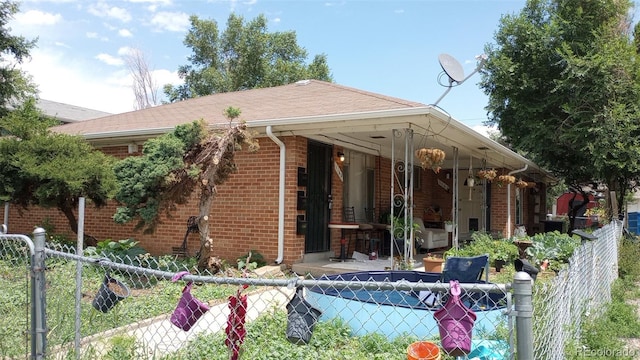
[[124, 48, 160, 110]]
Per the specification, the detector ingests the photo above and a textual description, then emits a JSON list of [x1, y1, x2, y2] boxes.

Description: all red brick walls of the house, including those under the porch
[[0, 136, 546, 264]]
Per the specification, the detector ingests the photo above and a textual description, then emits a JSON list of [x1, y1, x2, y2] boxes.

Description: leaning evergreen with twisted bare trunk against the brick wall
[[114, 107, 259, 268]]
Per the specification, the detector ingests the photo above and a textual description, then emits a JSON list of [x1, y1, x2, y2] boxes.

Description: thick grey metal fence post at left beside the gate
[[31, 228, 47, 360]]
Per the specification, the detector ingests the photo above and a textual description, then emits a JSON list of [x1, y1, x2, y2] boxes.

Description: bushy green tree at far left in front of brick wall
[[0, 99, 116, 240]]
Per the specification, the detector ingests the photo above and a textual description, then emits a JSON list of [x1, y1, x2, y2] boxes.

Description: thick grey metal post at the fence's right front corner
[[513, 271, 533, 360]]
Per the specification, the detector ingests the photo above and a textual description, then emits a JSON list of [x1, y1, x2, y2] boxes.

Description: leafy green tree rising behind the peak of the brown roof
[[164, 14, 331, 102]]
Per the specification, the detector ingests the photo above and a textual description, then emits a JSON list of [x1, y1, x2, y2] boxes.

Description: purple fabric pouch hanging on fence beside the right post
[[433, 280, 476, 356]]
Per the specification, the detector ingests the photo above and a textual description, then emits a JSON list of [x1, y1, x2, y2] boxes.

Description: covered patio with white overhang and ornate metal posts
[[251, 102, 552, 269]]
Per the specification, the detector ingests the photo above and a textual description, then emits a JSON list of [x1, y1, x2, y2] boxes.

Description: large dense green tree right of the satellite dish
[[481, 0, 640, 221]]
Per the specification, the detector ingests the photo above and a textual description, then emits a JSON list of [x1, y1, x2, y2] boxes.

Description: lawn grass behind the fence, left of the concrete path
[[0, 257, 237, 357]]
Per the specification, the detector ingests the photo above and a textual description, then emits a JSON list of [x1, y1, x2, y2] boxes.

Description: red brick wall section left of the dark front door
[[0, 137, 307, 263]]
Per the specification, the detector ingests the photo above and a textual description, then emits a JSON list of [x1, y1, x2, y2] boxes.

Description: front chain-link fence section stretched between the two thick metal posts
[[37, 248, 512, 359]]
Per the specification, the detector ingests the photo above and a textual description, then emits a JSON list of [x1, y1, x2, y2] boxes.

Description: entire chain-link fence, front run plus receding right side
[[0, 224, 621, 360]]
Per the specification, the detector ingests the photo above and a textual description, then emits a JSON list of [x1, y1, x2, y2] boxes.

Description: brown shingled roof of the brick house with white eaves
[[53, 80, 546, 177]]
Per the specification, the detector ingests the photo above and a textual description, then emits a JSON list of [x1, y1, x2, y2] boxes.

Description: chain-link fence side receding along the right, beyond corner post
[[533, 220, 622, 360]]
